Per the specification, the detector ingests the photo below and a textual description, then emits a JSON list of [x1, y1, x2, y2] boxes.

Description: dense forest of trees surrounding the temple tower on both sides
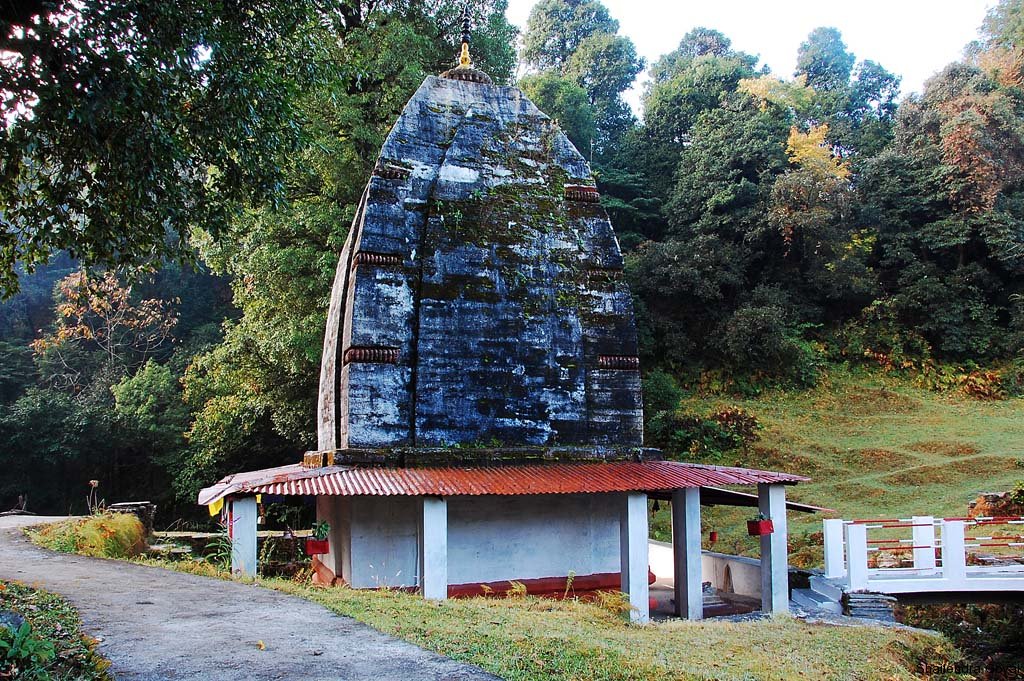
[[0, 0, 1024, 520]]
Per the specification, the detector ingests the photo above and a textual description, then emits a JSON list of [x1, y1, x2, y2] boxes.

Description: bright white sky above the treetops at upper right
[[508, 0, 995, 114]]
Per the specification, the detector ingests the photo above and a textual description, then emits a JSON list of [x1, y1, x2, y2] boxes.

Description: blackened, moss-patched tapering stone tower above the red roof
[[319, 78, 642, 449]]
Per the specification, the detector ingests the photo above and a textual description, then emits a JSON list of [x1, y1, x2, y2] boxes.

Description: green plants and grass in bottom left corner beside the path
[[0, 581, 111, 681]]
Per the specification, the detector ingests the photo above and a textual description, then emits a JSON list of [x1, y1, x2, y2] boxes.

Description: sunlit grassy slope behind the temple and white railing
[[652, 371, 1024, 562]]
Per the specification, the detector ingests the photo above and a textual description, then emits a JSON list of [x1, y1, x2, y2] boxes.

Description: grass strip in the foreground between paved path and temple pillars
[[263, 580, 958, 681]]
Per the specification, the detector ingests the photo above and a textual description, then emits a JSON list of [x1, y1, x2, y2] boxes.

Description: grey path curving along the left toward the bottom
[[0, 517, 497, 681]]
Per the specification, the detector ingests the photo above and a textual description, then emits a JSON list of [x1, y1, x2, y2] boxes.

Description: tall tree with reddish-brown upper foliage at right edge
[[862, 57, 1024, 359]]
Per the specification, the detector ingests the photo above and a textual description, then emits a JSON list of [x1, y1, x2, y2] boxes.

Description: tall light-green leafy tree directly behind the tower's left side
[[177, 0, 514, 495]]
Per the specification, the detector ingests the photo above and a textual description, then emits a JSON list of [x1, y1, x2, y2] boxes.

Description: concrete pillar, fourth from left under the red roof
[[672, 487, 703, 620]]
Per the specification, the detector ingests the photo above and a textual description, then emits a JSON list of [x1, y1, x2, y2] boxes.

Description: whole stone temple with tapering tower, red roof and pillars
[[200, 35, 804, 621]]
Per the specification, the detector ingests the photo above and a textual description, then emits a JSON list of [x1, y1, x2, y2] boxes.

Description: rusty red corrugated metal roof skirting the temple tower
[[199, 461, 809, 504]]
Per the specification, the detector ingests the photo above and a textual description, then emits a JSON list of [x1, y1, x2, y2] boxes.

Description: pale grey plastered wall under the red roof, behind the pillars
[[339, 495, 621, 589]]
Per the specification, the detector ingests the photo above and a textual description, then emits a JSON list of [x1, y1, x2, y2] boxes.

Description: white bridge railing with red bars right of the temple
[[824, 516, 1024, 593]]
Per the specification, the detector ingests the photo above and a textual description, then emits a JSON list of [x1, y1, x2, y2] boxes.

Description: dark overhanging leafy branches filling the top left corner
[[0, 0, 348, 293]]
